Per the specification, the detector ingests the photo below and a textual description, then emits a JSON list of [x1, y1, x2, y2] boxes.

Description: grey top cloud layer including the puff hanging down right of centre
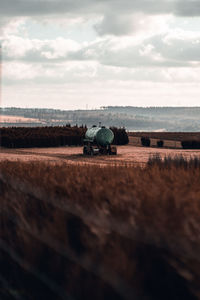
[[0, 0, 200, 35]]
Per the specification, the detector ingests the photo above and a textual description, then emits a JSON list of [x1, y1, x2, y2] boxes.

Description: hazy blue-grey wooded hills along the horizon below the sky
[[0, 106, 200, 132]]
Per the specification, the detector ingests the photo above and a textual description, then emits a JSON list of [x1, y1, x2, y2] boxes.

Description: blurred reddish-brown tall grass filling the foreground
[[0, 160, 200, 300]]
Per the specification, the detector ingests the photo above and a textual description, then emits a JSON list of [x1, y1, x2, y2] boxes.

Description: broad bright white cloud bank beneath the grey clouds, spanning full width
[[2, 15, 200, 68]]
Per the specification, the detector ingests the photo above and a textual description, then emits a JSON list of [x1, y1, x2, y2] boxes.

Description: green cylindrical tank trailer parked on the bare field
[[83, 125, 117, 155]]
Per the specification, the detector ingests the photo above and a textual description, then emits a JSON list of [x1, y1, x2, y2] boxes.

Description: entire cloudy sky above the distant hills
[[0, 0, 200, 109]]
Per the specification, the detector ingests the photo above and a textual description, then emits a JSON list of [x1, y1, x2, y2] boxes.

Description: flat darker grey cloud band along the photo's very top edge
[[1, 0, 200, 17]]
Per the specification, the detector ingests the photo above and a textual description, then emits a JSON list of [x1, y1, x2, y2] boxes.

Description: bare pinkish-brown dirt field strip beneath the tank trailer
[[0, 144, 200, 165]]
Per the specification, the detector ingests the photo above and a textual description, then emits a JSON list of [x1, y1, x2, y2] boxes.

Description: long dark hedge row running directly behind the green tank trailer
[[0, 124, 128, 148]]
